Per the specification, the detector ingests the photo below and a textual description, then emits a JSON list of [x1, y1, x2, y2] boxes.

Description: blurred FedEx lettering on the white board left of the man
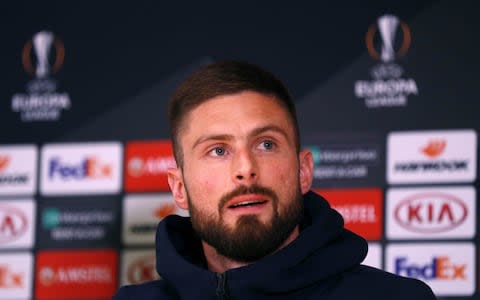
[[48, 156, 112, 179]]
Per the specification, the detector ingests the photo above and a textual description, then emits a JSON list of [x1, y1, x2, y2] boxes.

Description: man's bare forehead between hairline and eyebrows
[[180, 91, 293, 136]]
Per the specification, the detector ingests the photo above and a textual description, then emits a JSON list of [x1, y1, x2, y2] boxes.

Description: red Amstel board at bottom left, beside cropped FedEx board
[[35, 250, 118, 299]]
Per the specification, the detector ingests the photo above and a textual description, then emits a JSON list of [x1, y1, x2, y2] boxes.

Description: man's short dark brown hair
[[168, 61, 300, 167]]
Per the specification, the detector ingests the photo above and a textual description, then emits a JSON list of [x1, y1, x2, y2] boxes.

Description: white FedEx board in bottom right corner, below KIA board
[[386, 243, 476, 296]]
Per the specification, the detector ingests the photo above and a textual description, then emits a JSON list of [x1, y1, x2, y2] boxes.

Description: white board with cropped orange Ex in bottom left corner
[[0, 253, 33, 300]]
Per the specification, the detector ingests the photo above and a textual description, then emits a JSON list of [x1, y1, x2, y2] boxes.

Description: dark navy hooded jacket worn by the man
[[113, 192, 435, 300]]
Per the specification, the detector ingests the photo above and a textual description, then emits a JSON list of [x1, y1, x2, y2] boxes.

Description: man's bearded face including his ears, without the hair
[[169, 91, 313, 262]]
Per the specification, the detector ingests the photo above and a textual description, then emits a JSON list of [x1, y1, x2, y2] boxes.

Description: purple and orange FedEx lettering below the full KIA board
[[395, 256, 467, 280]]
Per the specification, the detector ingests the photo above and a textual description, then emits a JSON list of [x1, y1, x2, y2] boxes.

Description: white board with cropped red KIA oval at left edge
[[0, 199, 36, 249]]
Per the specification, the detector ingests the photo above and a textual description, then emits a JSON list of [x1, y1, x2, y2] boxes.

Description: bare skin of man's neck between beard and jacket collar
[[202, 226, 300, 273]]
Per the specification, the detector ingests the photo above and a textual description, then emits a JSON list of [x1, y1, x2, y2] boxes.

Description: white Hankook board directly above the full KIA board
[[387, 130, 477, 184]]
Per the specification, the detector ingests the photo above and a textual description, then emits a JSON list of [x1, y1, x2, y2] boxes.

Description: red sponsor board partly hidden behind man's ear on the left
[[125, 141, 176, 192]]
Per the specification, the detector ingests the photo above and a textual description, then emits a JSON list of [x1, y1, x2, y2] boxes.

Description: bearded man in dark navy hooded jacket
[[114, 61, 435, 300]]
